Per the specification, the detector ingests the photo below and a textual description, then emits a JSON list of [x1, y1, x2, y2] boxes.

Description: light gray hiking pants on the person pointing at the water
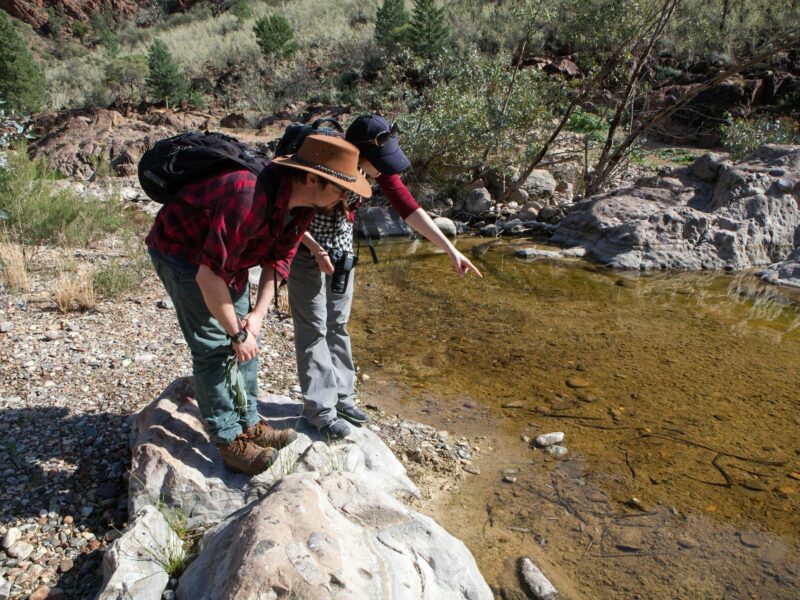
[[289, 246, 355, 427]]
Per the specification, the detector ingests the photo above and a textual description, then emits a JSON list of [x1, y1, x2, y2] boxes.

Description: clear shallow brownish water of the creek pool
[[351, 240, 800, 598]]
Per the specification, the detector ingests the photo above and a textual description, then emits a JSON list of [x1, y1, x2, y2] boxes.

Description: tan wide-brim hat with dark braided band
[[272, 134, 372, 198]]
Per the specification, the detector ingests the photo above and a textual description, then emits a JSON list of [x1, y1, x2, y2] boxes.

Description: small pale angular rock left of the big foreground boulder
[[97, 506, 185, 600]]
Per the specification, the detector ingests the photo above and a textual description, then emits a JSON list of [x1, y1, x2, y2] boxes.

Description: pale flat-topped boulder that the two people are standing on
[[128, 377, 419, 527]]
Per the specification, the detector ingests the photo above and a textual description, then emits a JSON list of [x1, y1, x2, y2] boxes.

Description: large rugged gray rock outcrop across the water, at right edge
[[553, 145, 800, 270]]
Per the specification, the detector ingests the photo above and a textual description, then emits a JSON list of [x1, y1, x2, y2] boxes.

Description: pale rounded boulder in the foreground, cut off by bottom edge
[[177, 471, 493, 600]]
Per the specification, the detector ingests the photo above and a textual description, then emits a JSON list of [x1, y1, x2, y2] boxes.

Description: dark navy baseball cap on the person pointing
[[345, 115, 411, 175]]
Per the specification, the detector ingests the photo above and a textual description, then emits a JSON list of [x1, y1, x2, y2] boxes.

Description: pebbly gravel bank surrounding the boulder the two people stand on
[[0, 251, 488, 599]]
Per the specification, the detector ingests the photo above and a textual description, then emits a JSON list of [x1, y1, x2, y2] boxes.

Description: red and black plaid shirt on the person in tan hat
[[145, 165, 315, 292]]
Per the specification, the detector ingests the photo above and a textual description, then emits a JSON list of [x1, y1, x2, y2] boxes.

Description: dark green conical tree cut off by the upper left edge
[[0, 10, 44, 112]]
